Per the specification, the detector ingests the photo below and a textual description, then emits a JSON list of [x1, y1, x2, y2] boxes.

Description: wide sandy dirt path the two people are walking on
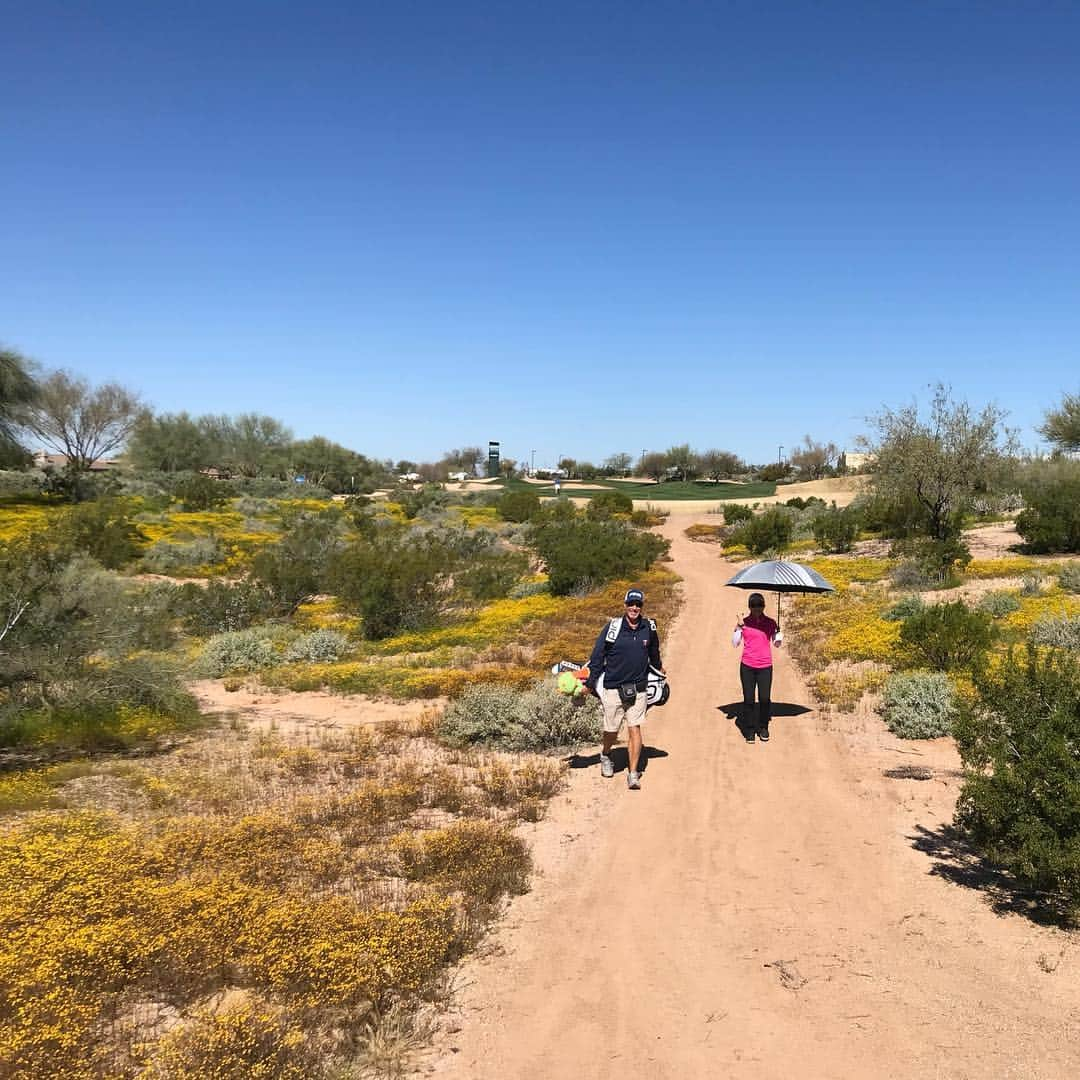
[[421, 514, 1080, 1080]]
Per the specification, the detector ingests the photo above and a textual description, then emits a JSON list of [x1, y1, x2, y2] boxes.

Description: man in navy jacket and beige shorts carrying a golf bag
[[585, 589, 664, 791]]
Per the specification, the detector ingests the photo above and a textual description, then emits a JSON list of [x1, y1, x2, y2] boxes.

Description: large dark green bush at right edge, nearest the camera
[[955, 646, 1080, 912]]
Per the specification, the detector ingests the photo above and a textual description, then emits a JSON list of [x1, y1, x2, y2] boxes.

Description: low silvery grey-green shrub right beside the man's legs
[[438, 679, 600, 751]]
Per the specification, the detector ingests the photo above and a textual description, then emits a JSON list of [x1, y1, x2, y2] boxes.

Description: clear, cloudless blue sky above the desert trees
[[0, 0, 1080, 465]]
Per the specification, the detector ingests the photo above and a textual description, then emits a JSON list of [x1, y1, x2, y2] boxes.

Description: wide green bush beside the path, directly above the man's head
[[530, 518, 670, 596]]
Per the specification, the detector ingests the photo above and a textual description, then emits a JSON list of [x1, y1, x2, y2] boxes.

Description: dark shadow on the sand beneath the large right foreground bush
[[907, 825, 1074, 928]]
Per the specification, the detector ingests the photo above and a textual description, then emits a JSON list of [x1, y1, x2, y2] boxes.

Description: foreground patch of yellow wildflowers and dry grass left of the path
[[0, 715, 565, 1078]]
